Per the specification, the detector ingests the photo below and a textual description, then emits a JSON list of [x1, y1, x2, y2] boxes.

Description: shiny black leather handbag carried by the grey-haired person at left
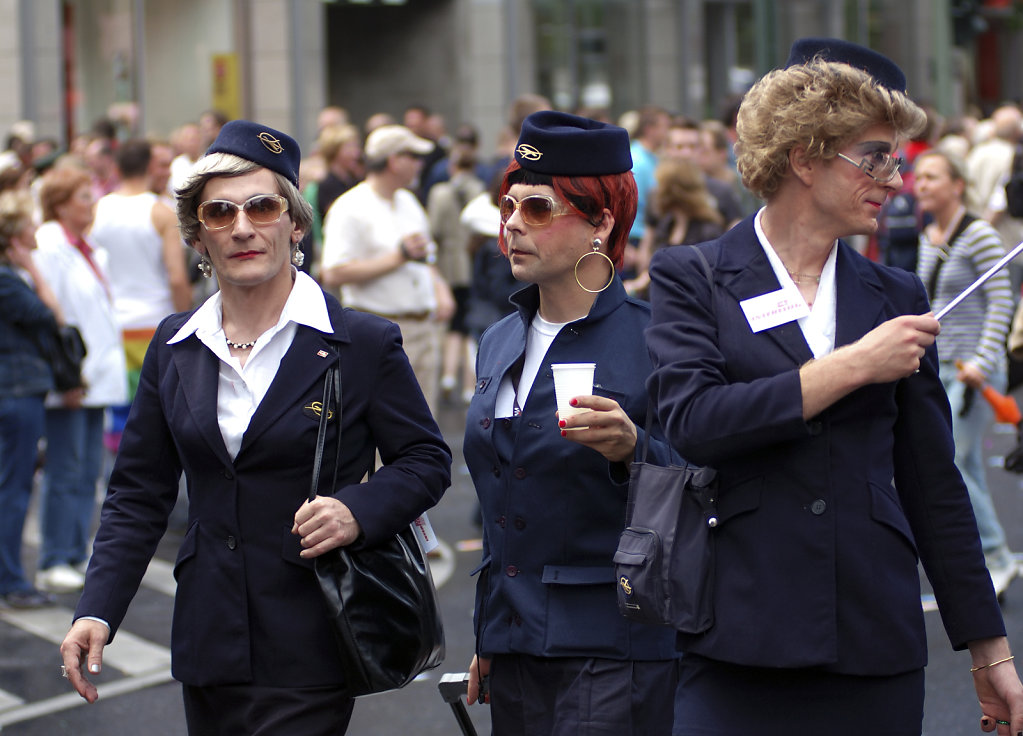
[[309, 364, 444, 697]]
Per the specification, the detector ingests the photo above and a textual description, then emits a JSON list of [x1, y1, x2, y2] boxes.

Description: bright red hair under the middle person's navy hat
[[497, 160, 637, 268]]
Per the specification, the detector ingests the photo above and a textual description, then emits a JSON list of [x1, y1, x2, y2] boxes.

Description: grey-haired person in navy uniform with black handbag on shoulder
[[60, 121, 451, 736]]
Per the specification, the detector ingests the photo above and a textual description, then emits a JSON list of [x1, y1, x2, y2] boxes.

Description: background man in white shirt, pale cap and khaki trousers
[[320, 125, 454, 409]]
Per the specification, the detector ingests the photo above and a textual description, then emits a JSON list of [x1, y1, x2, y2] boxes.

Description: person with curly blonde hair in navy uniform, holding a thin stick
[[647, 39, 1023, 736]]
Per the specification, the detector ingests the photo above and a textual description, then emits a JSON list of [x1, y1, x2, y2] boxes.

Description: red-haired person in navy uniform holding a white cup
[[462, 111, 676, 736]]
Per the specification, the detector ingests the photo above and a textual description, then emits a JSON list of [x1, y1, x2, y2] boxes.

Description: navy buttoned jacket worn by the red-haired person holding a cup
[[462, 277, 675, 659]]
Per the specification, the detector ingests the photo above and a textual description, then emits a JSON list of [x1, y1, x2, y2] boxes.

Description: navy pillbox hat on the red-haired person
[[515, 110, 632, 176]]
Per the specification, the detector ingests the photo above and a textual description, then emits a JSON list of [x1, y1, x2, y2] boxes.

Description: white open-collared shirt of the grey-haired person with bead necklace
[[167, 267, 333, 460]]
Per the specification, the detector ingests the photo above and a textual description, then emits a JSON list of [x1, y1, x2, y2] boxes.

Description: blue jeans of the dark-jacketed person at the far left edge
[[0, 395, 43, 596]]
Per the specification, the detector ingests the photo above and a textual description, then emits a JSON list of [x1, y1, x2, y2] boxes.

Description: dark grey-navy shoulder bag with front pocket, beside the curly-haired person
[[614, 246, 718, 634]]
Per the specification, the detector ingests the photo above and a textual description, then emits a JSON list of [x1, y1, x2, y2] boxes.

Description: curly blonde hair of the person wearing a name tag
[[736, 57, 927, 201]]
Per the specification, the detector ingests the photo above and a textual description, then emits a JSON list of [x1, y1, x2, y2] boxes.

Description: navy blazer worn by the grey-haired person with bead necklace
[[75, 296, 451, 687]]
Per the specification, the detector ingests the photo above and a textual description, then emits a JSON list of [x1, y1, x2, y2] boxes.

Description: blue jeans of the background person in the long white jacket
[[39, 407, 103, 570]]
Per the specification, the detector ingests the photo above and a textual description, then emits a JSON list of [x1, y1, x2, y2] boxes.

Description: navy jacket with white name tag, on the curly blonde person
[[647, 218, 1005, 675]]
